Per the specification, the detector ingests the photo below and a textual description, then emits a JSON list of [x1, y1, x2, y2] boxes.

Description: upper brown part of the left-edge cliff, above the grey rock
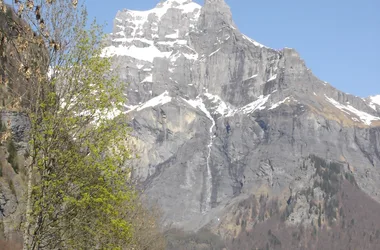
[[0, 6, 48, 111]]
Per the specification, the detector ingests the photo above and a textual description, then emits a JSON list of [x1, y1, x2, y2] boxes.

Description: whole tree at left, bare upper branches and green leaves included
[[0, 0, 164, 250]]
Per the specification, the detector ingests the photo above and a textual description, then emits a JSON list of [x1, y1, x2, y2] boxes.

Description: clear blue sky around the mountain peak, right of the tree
[[87, 0, 380, 97]]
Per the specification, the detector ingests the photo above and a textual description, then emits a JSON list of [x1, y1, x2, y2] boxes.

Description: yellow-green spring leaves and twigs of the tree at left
[[20, 4, 163, 249]]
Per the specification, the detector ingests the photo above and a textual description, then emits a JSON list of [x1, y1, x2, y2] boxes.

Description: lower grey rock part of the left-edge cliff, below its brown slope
[[0, 111, 30, 242]]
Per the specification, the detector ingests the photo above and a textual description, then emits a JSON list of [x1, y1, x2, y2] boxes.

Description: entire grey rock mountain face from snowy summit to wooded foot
[[104, 0, 380, 246]]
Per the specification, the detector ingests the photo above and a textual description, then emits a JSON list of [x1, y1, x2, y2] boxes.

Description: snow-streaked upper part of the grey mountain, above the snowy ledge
[[104, 0, 380, 130]]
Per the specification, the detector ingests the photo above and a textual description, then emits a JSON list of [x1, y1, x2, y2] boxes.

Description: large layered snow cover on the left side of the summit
[[102, 0, 201, 63]]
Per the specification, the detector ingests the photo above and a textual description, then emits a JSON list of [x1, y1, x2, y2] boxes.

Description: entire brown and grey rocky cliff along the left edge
[[0, 8, 35, 242]]
